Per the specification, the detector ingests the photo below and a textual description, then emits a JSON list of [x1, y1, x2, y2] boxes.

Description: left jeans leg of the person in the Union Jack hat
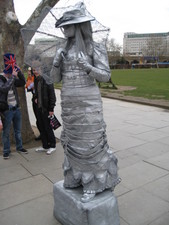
[[2, 110, 13, 154]]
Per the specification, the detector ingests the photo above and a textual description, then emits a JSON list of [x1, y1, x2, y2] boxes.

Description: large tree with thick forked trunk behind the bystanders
[[0, 0, 59, 146]]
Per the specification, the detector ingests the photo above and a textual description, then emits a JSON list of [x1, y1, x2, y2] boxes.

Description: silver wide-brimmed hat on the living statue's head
[[55, 8, 95, 27]]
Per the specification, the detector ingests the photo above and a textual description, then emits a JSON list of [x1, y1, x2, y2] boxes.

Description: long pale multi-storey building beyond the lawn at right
[[123, 32, 169, 57]]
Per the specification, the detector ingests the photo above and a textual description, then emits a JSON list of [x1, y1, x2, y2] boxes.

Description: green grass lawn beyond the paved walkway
[[101, 68, 169, 100]]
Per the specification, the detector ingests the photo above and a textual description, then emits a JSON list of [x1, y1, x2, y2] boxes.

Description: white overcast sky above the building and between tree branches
[[14, 0, 169, 45]]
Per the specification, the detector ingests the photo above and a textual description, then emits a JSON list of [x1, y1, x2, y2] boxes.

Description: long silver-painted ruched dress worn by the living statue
[[50, 44, 120, 193]]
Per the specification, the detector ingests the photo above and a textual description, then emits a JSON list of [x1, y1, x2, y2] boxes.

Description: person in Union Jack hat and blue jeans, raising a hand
[[0, 53, 28, 159]]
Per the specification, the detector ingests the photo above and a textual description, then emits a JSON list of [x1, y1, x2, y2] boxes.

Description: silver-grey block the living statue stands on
[[53, 181, 120, 225]]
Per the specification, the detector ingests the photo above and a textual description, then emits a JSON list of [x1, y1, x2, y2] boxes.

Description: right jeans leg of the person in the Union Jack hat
[[13, 108, 22, 151]]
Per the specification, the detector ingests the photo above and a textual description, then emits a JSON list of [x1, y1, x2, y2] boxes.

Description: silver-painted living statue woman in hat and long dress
[[50, 3, 120, 202]]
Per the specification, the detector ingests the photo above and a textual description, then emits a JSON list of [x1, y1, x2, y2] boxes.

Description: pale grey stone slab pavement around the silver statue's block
[[0, 90, 169, 225]]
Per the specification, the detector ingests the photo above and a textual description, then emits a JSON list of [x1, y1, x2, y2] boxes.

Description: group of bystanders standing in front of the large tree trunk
[[0, 53, 56, 159]]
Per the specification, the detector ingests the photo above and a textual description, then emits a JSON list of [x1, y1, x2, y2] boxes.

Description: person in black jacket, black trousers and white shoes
[[33, 69, 56, 155]]
